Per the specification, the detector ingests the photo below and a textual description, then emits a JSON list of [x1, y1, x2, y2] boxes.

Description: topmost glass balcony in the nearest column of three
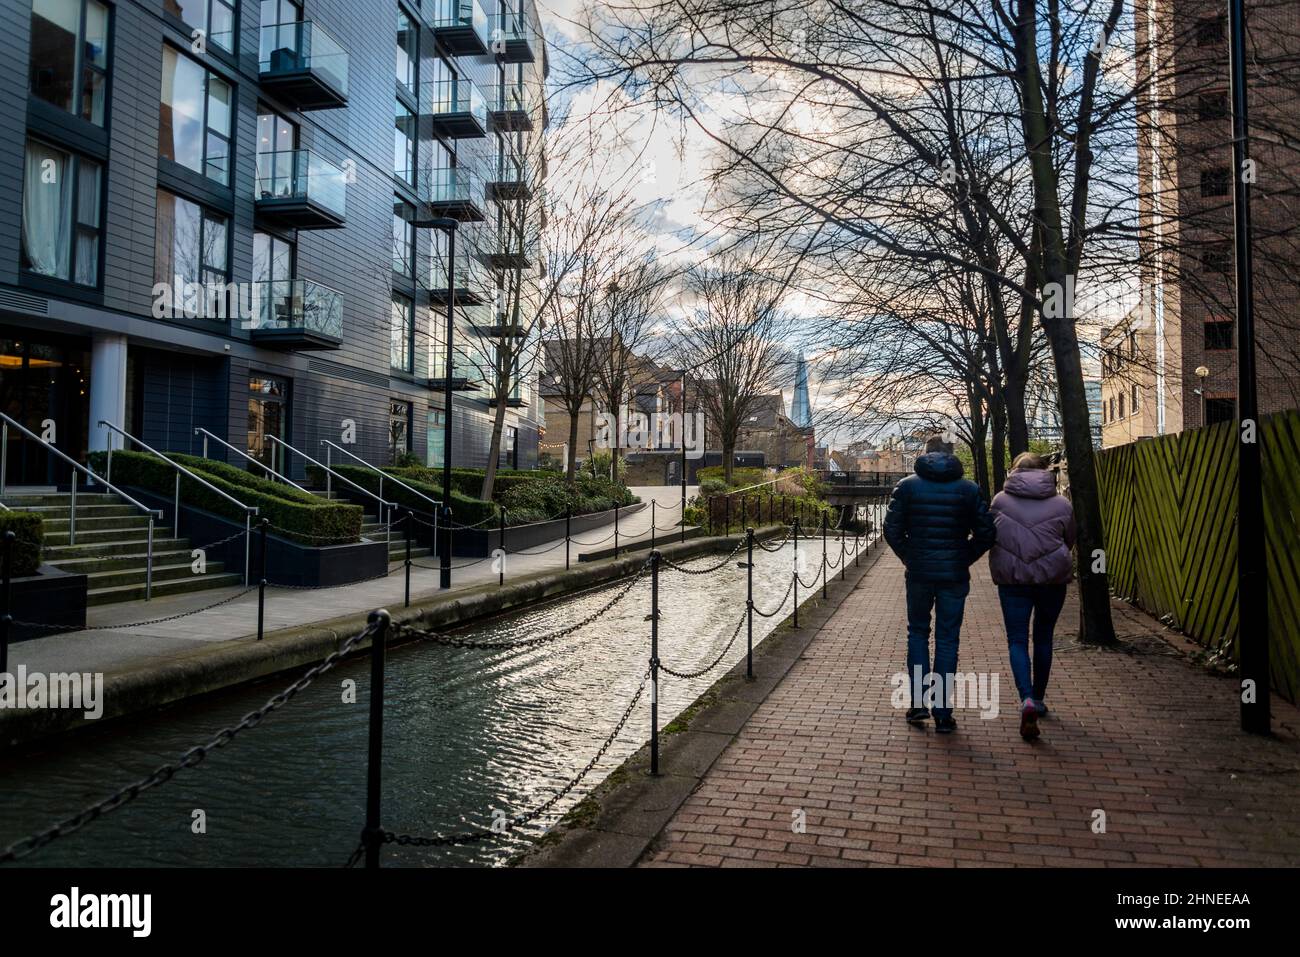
[[257, 20, 347, 109]]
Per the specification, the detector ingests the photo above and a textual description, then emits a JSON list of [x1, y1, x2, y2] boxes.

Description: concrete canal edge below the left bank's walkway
[[0, 527, 784, 750]]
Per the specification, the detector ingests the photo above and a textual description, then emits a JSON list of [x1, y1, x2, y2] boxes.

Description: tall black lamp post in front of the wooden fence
[[1227, 0, 1269, 735]]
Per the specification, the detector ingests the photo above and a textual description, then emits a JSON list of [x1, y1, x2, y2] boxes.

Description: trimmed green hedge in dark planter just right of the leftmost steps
[[90, 451, 363, 545]]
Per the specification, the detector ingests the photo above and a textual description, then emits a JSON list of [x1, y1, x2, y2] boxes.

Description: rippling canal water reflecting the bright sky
[[0, 542, 852, 867]]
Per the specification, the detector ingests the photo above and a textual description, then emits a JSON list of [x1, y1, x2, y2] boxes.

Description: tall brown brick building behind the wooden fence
[[1118, 0, 1300, 446]]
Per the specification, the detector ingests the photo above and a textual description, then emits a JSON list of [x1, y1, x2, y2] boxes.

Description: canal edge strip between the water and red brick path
[[510, 540, 887, 867]]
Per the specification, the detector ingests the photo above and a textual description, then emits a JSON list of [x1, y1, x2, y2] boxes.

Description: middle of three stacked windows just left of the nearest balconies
[[159, 46, 234, 186]]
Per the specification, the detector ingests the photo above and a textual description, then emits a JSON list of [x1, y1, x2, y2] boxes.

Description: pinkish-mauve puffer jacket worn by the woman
[[988, 468, 1075, 585]]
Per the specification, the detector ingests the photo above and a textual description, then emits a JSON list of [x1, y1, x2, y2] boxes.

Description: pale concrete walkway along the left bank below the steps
[[9, 486, 696, 675]]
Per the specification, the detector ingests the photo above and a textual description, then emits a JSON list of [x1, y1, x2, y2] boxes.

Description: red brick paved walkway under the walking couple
[[642, 546, 1300, 867]]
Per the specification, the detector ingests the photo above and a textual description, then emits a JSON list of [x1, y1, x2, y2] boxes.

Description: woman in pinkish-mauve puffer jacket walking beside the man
[[988, 452, 1075, 741]]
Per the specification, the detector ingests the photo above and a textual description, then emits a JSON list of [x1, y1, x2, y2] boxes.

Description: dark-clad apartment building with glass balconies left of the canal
[[0, 0, 546, 484]]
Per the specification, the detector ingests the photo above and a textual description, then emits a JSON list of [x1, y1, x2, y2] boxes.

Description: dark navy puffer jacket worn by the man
[[885, 452, 993, 581]]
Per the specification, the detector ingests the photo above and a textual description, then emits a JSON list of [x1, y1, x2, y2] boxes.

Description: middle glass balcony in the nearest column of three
[[255, 150, 347, 229]]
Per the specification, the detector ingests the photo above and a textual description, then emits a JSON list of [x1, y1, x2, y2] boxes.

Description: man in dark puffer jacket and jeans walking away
[[884, 436, 995, 733]]
